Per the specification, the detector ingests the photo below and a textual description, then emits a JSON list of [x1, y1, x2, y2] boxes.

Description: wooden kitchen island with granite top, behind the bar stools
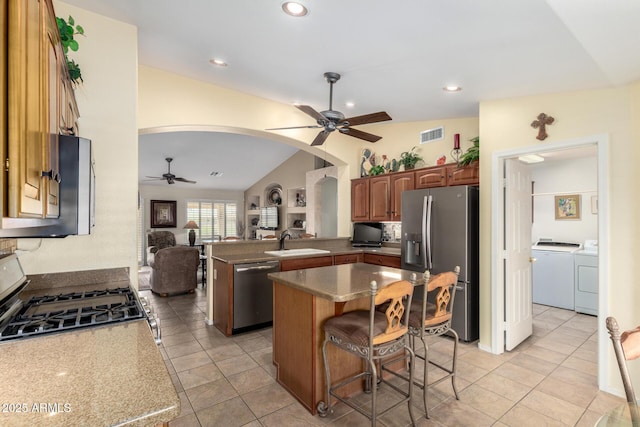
[[269, 263, 414, 415]]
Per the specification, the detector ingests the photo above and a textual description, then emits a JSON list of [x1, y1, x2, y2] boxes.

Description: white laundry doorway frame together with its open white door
[[491, 135, 609, 390]]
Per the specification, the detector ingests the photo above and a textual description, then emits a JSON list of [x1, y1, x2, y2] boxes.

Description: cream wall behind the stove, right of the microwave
[[18, 1, 138, 283]]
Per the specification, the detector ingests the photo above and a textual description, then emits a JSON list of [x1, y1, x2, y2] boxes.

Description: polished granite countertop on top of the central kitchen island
[[269, 263, 421, 302]]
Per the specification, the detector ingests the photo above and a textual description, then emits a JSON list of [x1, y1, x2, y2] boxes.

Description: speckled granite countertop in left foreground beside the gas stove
[[0, 320, 180, 426]]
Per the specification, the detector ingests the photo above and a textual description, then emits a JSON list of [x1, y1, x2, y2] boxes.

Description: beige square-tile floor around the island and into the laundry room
[[141, 288, 624, 427]]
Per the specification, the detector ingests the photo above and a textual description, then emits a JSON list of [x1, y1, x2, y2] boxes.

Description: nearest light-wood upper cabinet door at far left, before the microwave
[[7, 0, 48, 218]]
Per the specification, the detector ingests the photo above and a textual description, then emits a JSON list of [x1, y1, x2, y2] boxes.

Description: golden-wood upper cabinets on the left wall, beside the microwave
[[2, 0, 77, 218]]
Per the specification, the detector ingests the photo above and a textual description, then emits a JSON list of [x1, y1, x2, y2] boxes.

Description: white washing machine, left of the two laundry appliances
[[531, 241, 581, 310]]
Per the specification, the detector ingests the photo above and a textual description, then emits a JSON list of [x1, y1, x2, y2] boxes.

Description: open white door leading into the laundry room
[[504, 159, 533, 351]]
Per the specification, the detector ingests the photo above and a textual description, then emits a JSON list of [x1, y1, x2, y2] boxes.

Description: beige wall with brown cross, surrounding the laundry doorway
[[480, 83, 640, 394]]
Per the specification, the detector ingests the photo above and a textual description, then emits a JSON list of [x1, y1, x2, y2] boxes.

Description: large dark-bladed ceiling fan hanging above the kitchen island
[[266, 72, 391, 145]]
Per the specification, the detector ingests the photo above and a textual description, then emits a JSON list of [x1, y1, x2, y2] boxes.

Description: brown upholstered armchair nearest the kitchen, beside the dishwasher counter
[[149, 246, 200, 296]]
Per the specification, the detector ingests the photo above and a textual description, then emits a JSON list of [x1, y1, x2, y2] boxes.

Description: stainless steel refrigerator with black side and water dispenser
[[401, 185, 480, 341]]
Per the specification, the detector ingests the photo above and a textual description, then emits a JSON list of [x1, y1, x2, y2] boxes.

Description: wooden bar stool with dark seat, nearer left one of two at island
[[318, 280, 415, 426]]
